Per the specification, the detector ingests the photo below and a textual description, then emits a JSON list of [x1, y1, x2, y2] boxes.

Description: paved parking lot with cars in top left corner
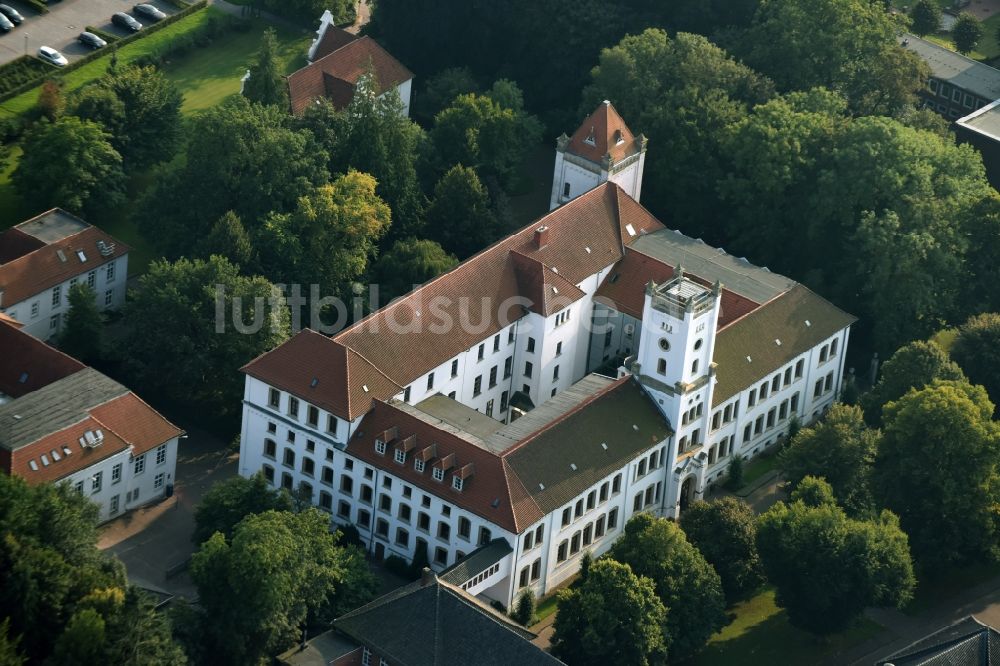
[[0, 0, 177, 64]]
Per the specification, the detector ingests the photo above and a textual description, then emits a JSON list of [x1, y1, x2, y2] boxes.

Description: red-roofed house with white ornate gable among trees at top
[[286, 11, 413, 116]]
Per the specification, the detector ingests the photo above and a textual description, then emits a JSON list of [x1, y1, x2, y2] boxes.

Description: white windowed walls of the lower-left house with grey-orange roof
[[59, 437, 178, 523]]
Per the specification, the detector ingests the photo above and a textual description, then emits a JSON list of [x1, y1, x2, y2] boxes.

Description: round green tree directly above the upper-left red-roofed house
[[11, 116, 125, 218]]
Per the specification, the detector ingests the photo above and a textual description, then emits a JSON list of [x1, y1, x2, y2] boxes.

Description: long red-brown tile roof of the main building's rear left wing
[[243, 183, 663, 420]]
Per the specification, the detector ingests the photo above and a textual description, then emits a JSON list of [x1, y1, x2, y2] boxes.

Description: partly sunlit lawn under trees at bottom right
[[691, 590, 882, 666]]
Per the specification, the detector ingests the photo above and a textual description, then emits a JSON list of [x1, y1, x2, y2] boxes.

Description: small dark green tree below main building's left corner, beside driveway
[[191, 473, 292, 544]]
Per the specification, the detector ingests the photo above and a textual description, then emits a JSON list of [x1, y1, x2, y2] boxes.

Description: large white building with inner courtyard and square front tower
[[240, 105, 854, 604]]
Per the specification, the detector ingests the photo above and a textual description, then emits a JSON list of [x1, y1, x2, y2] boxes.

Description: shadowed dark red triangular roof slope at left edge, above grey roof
[[0, 317, 87, 398]]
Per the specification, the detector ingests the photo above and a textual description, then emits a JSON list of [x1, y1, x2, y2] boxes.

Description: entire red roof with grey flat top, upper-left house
[[0, 209, 129, 308]]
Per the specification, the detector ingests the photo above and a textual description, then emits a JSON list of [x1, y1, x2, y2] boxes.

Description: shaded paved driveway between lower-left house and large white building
[[97, 419, 238, 599]]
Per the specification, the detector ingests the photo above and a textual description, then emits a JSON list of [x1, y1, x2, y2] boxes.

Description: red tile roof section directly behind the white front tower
[[594, 248, 761, 331]]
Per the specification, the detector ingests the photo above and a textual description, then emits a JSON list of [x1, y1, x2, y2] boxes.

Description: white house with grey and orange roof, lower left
[[0, 317, 182, 522]]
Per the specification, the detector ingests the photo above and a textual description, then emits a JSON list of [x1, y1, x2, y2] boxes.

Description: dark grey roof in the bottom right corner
[[875, 615, 1000, 666]]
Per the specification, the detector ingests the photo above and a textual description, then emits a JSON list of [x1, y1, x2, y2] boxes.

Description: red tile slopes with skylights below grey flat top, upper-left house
[[0, 226, 129, 308]]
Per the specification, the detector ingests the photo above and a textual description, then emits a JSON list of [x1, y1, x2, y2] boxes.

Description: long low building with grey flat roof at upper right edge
[[900, 35, 1000, 120]]
